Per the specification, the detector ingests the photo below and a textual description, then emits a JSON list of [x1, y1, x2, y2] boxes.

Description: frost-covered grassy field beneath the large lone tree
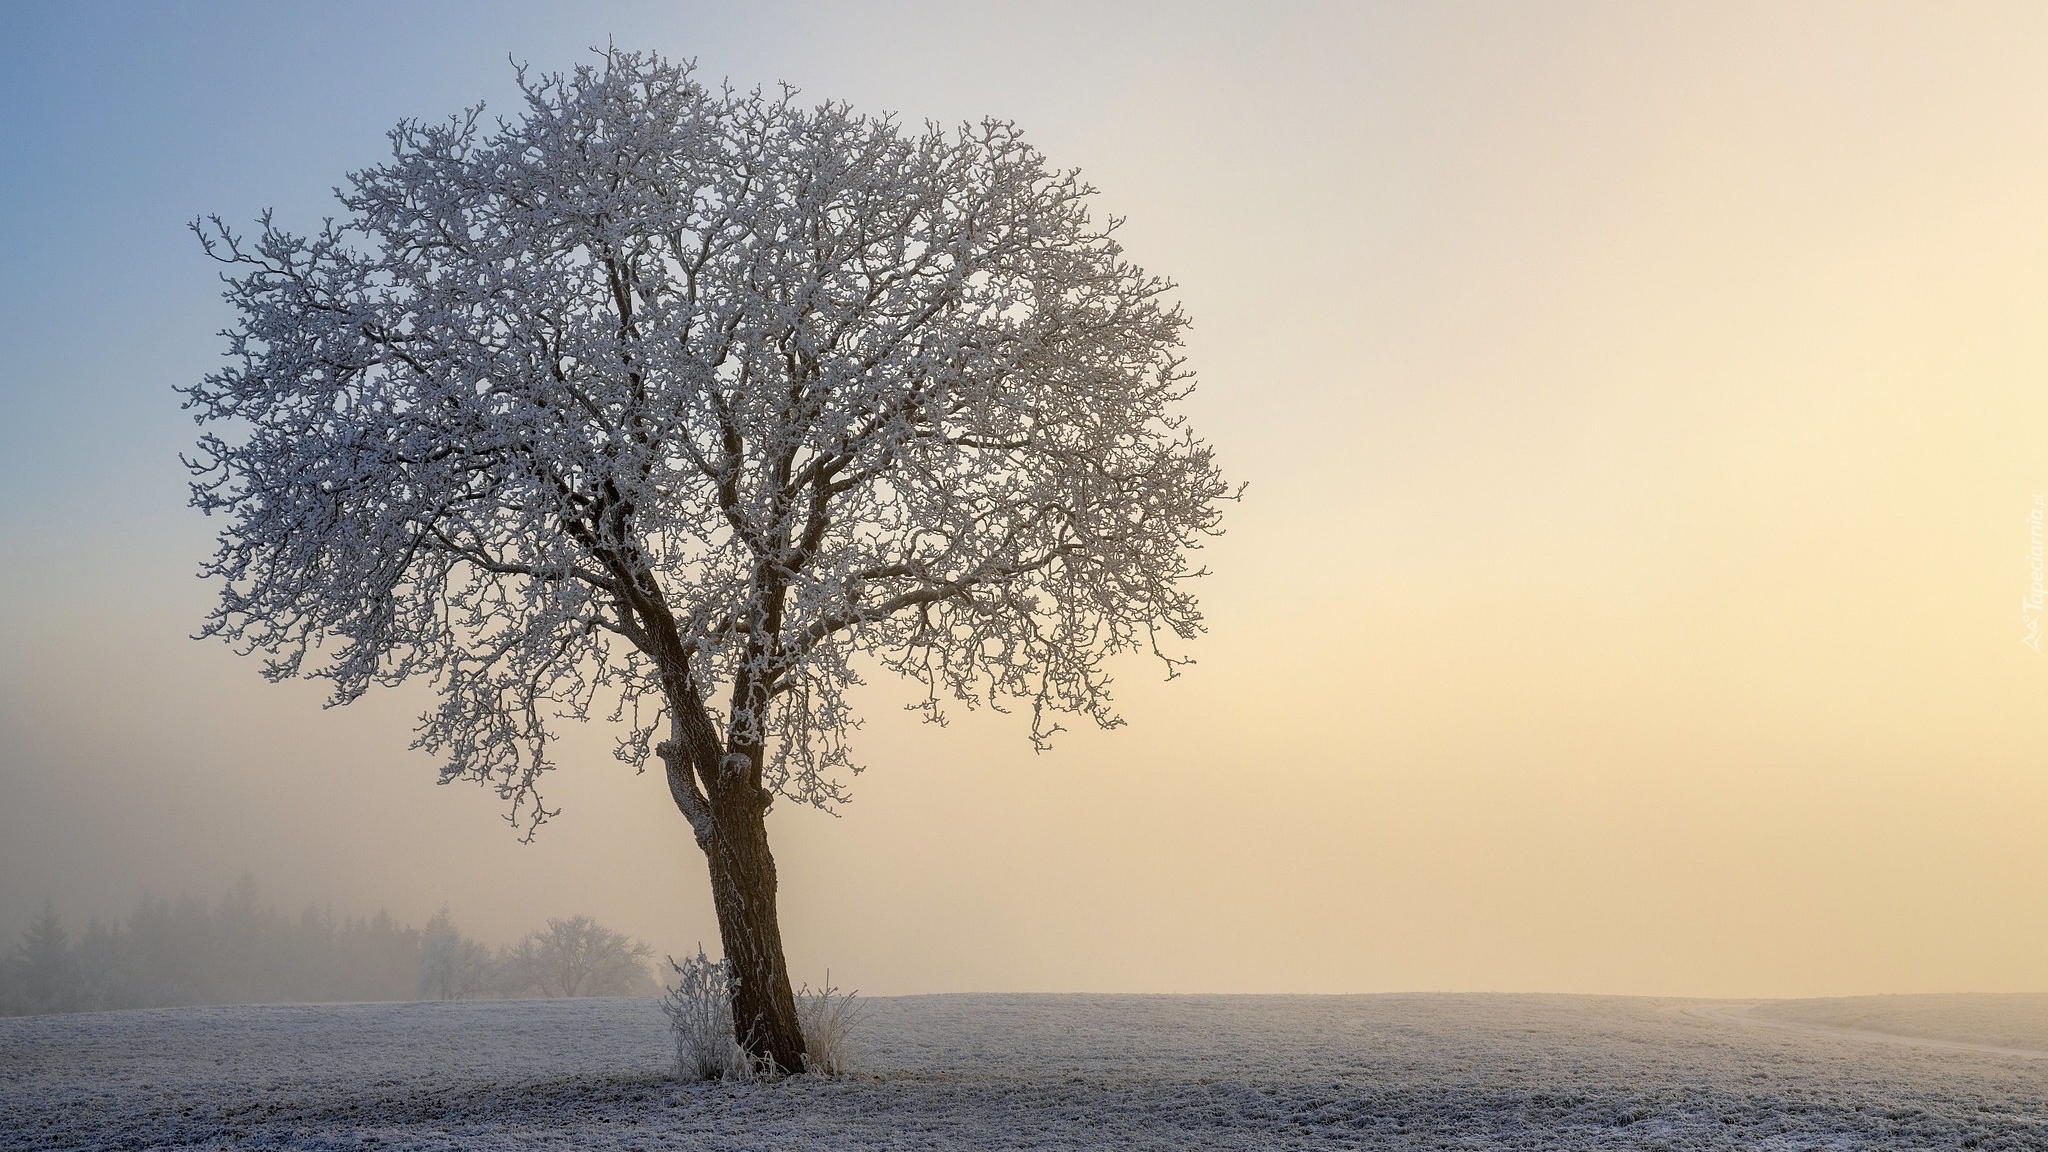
[[0, 996, 2048, 1150]]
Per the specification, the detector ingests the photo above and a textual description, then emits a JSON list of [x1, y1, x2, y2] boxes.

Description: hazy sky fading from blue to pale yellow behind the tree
[[0, 2, 2048, 996]]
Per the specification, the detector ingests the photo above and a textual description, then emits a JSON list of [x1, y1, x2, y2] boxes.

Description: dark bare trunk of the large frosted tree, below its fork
[[705, 789, 803, 1072]]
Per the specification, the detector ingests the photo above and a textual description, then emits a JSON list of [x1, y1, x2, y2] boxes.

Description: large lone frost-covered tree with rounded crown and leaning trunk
[[186, 51, 1231, 1072]]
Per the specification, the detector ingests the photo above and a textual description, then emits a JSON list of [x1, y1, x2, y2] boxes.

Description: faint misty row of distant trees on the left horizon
[[0, 877, 662, 1015]]
